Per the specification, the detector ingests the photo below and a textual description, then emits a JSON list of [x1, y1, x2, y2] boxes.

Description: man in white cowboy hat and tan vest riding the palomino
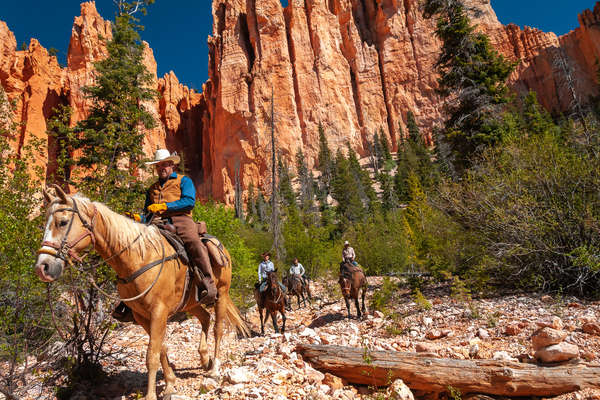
[[113, 149, 217, 319]]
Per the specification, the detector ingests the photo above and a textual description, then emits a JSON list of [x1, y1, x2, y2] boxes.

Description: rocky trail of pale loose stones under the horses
[[19, 277, 600, 400]]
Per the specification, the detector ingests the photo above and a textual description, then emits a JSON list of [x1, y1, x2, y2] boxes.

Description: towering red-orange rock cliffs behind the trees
[[0, 0, 600, 203]]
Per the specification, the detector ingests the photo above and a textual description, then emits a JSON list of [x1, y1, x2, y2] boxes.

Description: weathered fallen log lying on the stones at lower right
[[296, 345, 600, 397]]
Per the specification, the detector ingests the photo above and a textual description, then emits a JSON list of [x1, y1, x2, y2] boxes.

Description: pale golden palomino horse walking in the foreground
[[35, 185, 249, 400]]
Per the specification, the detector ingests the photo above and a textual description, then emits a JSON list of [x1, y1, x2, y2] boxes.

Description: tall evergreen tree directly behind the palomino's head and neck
[[76, 0, 156, 210]]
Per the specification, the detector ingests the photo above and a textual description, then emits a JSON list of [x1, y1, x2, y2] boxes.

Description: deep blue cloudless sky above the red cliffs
[[0, 0, 595, 90]]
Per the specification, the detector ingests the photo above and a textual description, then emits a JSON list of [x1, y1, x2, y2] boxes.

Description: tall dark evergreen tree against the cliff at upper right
[[424, 0, 514, 167]]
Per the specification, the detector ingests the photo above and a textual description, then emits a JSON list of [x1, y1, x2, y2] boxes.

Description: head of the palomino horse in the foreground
[[34, 185, 96, 282]]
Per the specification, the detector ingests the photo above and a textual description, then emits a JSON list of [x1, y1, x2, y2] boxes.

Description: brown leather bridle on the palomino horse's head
[[37, 198, 98, 266]]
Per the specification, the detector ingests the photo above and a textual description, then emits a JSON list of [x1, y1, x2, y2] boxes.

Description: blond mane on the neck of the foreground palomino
[[72, 194, 162, 258]]
